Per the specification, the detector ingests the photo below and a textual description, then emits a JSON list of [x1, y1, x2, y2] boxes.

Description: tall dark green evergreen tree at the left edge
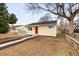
[[0, 3, 9, 33]]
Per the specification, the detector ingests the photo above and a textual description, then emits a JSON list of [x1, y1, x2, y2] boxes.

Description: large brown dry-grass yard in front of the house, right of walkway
[[0, 36, 78, 56]]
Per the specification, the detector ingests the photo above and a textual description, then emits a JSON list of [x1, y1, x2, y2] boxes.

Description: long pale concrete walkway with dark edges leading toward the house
[[0, 35, 35, 50]]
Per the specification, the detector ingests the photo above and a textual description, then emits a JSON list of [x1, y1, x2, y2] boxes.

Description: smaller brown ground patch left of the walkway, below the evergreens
[[0, 32, 23, 43]]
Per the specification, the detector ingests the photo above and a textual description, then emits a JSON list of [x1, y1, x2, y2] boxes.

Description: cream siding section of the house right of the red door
[[38, 26, 56, 36]]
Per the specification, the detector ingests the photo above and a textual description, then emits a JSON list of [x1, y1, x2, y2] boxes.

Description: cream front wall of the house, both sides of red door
[[26, 26, 57, 37]]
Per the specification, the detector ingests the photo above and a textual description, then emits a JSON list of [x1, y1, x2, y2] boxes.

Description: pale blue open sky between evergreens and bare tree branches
[[6, 3, 47, 25]]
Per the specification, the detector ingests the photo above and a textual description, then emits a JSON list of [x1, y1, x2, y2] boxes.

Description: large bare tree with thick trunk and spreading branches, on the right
[[26, 3, 79, 33]]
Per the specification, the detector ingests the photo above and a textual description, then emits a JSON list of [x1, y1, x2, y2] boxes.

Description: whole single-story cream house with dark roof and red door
[[25, 20, 57, 37]]
